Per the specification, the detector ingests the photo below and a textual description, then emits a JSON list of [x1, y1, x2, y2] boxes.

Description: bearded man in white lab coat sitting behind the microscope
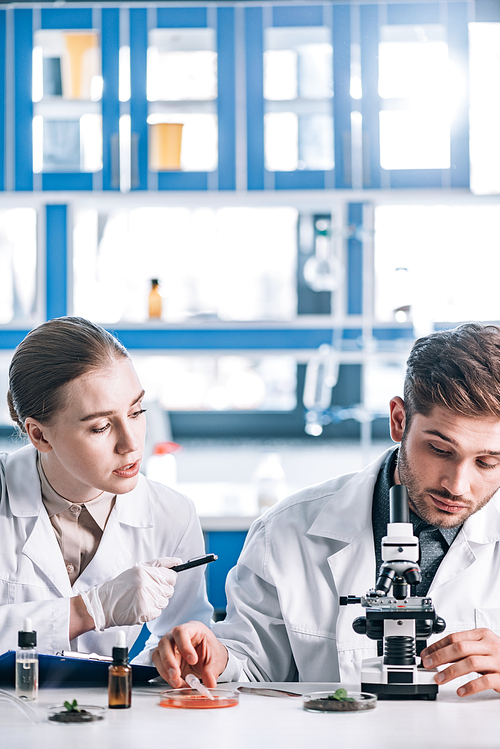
[[153, 323, 500, 696]]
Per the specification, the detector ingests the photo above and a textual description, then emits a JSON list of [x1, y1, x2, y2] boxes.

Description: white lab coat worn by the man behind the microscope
[[213, 453, 500, 684]]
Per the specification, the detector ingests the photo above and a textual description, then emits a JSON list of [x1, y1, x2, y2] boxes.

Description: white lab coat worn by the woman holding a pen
[[0, 445, 212, 655]]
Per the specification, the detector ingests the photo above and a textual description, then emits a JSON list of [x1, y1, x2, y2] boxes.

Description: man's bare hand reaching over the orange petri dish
[[152, 622, 228, 689]]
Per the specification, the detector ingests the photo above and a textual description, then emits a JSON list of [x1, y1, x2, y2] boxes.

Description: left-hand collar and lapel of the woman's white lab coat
[[5, 445, 71, 596]]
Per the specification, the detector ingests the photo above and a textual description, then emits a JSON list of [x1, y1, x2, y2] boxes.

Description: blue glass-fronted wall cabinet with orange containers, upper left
[[0, 6, 235, 191]]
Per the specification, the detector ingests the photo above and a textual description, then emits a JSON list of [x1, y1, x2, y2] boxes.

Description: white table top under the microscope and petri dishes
[[0, 684, 500, 749]]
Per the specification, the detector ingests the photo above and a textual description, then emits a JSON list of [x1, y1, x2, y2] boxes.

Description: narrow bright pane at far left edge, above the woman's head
[[0, 208, 37, 325]]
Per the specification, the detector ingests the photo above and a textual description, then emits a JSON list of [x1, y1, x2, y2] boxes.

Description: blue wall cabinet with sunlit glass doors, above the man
[[246, 2, 469, 190]]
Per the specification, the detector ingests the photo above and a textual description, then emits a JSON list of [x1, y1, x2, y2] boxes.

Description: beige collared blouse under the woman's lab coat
[[37, 455, 116, 585]]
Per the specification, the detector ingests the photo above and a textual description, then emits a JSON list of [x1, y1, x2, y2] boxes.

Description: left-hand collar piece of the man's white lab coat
[[308, 448, 394, 544]]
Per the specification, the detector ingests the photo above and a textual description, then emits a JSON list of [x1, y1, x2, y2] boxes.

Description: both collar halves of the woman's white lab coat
[[5, 445, 153, 528]]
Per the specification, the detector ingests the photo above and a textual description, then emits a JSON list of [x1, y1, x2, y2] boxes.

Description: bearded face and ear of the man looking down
[[391, 398, 500, 528]]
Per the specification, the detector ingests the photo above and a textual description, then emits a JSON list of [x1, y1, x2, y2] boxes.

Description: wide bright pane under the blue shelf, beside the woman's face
[[133, 354, 297, 411]]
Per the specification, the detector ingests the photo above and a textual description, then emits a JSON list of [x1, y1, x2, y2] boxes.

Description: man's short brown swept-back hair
[[404, 323, 500, 429]]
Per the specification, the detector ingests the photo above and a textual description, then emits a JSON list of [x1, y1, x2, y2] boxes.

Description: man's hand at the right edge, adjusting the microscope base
[[422, 629, 500, 697]]
